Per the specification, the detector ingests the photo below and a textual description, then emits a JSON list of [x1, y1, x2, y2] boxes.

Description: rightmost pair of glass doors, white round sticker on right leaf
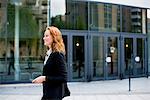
[[124, 37, 147, 77]]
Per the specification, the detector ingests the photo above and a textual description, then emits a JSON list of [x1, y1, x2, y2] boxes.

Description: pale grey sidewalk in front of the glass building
[[0, 78, 150, 100]]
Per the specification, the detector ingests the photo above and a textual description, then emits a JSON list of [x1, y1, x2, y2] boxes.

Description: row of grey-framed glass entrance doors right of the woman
[[61, 31, 148, 81]]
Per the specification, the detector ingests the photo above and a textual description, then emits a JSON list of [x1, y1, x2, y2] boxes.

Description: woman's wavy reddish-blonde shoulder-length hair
[[46, 26, 66, 54]]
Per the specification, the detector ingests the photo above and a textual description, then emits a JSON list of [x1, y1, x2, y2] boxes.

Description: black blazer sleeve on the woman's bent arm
[[46, 52, 67, 83]]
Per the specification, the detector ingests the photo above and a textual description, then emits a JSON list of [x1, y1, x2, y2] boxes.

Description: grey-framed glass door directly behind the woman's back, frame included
[[62, 31, 87, 81]]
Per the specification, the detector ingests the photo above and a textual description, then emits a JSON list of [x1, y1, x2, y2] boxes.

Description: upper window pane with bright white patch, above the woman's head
[[51, 0, 88, 30]]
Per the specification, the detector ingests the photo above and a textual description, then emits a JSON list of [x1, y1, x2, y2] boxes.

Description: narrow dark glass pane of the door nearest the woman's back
[[73, 36, 85, 79]]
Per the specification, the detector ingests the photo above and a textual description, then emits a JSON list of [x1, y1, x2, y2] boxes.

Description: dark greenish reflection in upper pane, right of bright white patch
[[65, 0, 88, 30]]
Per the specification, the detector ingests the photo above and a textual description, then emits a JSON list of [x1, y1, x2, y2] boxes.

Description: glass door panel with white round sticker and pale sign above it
[[104, 36, 119, 79]]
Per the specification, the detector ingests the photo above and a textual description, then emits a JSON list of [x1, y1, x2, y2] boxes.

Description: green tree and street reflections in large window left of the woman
[[0, 0, 47, 82]]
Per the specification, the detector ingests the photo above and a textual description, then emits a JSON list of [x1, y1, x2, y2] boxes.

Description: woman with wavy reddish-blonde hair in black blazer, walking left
[[32, 26, 70, 100]]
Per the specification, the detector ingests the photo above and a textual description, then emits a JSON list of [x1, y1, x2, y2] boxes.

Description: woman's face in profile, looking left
[[43, 30, 53, 47]]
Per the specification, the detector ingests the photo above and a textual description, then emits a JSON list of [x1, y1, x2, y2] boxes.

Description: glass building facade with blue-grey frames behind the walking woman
[[0, 0, 150, 83]]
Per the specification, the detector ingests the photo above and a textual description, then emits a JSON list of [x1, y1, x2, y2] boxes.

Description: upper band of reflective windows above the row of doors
[[51, 0, 147, 34]]
